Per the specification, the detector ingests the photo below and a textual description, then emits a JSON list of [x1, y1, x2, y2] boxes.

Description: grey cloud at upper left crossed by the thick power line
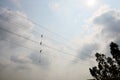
[[0, 8, 33, 46]]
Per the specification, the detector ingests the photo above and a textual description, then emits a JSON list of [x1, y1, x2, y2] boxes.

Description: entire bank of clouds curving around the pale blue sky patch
[[0, 6, 120, 80]]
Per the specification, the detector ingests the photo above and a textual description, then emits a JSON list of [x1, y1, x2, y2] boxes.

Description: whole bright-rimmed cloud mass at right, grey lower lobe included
[[78, 5, 120, 60]]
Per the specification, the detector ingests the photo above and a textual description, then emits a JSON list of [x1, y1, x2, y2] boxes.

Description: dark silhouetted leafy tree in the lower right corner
[[89, 42, 120, 80]]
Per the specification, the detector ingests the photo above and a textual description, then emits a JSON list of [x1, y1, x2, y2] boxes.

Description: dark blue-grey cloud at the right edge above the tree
[[93, 10, 120, 40]]
